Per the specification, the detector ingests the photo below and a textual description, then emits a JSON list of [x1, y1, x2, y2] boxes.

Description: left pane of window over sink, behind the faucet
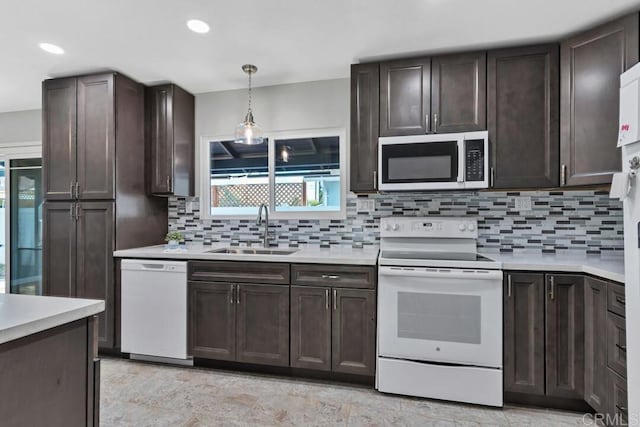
[[209, 140, 269, 215]]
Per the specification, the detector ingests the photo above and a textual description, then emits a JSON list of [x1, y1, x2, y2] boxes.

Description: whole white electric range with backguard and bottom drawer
[[376, 217, 503, 406]]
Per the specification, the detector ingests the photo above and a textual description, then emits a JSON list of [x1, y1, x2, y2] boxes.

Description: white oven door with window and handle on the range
[[378, 266, 502, 368]]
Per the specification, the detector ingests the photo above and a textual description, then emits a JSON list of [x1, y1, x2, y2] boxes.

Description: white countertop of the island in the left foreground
[[0, 294, 104, 344]]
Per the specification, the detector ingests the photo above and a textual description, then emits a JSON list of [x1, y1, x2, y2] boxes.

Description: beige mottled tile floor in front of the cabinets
[[100, 358, 592, 427]]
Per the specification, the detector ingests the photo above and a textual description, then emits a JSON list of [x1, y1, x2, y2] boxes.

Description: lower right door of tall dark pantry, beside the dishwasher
[[76, 202, 115, 348]]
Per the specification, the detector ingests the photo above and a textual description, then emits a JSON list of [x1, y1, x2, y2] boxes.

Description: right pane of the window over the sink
[[274, 136, 340, 212]]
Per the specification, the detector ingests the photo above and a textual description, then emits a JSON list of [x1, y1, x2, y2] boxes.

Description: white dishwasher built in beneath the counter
[[121, 259, 192, 364]]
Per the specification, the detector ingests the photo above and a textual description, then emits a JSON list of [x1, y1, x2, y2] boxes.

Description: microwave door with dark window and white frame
[[378, 134, 464, 191]]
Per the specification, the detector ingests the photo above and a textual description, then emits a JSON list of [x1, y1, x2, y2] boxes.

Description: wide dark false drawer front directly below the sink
[[188, 261, 290, 285]]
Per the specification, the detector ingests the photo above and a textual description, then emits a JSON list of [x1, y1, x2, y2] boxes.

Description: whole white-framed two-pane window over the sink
[[199, 129, 346, 219]]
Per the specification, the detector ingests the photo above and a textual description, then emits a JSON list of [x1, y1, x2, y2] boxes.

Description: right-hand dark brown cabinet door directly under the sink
[[236, 284, 289, 366]]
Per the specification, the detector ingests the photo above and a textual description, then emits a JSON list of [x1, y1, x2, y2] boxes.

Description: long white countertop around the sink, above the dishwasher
[[113, 243, 378, 265]]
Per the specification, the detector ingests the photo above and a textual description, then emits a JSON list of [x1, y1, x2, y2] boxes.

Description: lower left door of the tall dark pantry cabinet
[[42, 202, 76, 297]]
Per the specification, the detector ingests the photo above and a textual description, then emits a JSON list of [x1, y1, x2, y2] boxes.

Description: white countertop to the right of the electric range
[[482, 253, 624, 283]]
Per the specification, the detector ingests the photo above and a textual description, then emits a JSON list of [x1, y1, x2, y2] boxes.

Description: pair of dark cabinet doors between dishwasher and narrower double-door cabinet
[[188, 281, 289, 366]]
